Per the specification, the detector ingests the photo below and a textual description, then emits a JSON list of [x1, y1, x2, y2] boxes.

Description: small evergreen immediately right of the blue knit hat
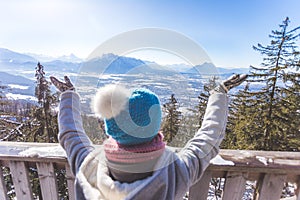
[[161, 94, 181, 142]]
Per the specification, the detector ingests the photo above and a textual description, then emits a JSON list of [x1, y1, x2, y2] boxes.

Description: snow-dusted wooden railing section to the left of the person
[[0, 142, 74, 200]]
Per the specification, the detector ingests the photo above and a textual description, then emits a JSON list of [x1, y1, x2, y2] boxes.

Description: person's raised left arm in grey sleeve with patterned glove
[[50, 76, 94, 174]]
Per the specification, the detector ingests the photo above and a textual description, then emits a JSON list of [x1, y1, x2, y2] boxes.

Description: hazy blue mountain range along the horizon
[[0, 48, 248, 74]]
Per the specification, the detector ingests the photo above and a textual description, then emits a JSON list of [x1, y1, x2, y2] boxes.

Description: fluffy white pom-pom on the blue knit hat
[[92, 85, 131, 119]]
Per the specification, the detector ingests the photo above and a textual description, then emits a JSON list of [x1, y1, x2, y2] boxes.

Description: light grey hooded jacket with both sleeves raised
[[58, 91, 228, 200]]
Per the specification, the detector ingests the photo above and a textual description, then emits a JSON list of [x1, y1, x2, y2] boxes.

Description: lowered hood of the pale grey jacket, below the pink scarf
[[77, 148, 178, 200]]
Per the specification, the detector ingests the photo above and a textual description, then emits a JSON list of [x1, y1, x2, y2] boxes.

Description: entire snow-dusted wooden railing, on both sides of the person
[[0, 142, 300, 200]]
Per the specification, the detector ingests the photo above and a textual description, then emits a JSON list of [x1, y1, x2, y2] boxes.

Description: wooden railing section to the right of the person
[[189, 150, 300, 200]]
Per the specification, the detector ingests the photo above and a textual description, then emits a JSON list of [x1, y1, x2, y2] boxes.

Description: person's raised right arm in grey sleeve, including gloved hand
[[180, 75, 247, 184]]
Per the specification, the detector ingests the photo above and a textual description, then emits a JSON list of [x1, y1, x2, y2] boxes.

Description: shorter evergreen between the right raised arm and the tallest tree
[[221, 84, 264, 149]]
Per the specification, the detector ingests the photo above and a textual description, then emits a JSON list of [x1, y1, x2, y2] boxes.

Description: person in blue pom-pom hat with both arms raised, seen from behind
[[50, 75, 247, 200]]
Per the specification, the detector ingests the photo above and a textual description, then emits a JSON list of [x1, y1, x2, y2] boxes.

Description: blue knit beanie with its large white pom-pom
[[93, 85, 161, 145]]
